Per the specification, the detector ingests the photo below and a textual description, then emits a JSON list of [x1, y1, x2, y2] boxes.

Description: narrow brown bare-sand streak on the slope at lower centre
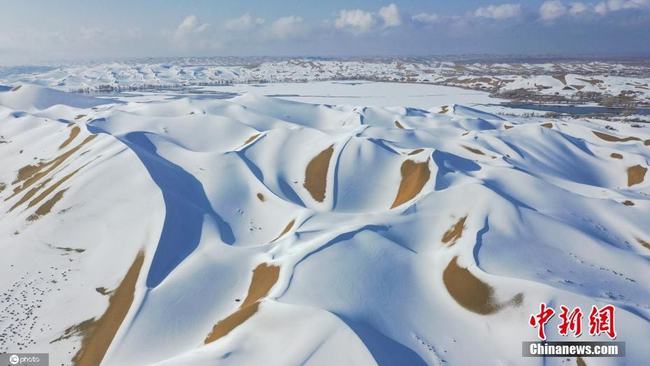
[[203, 263, 280, 344]]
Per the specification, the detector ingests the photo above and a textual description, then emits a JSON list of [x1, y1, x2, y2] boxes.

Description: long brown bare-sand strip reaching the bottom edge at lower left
[[72, 252, 144, 366]]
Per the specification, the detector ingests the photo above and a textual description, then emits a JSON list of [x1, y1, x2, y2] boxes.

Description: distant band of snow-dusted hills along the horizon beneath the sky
[[0, 58, 650, 107]]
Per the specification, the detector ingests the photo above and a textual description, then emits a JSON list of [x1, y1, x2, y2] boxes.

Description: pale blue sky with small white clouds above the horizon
[[0, 0, 650, 64]]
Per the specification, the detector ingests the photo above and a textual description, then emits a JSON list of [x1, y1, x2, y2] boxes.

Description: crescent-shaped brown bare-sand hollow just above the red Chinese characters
[[442, 257, 524, 315]]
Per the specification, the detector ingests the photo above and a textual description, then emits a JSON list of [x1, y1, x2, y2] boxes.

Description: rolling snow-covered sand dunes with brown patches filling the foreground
[[0, 85, 650, 365]]
